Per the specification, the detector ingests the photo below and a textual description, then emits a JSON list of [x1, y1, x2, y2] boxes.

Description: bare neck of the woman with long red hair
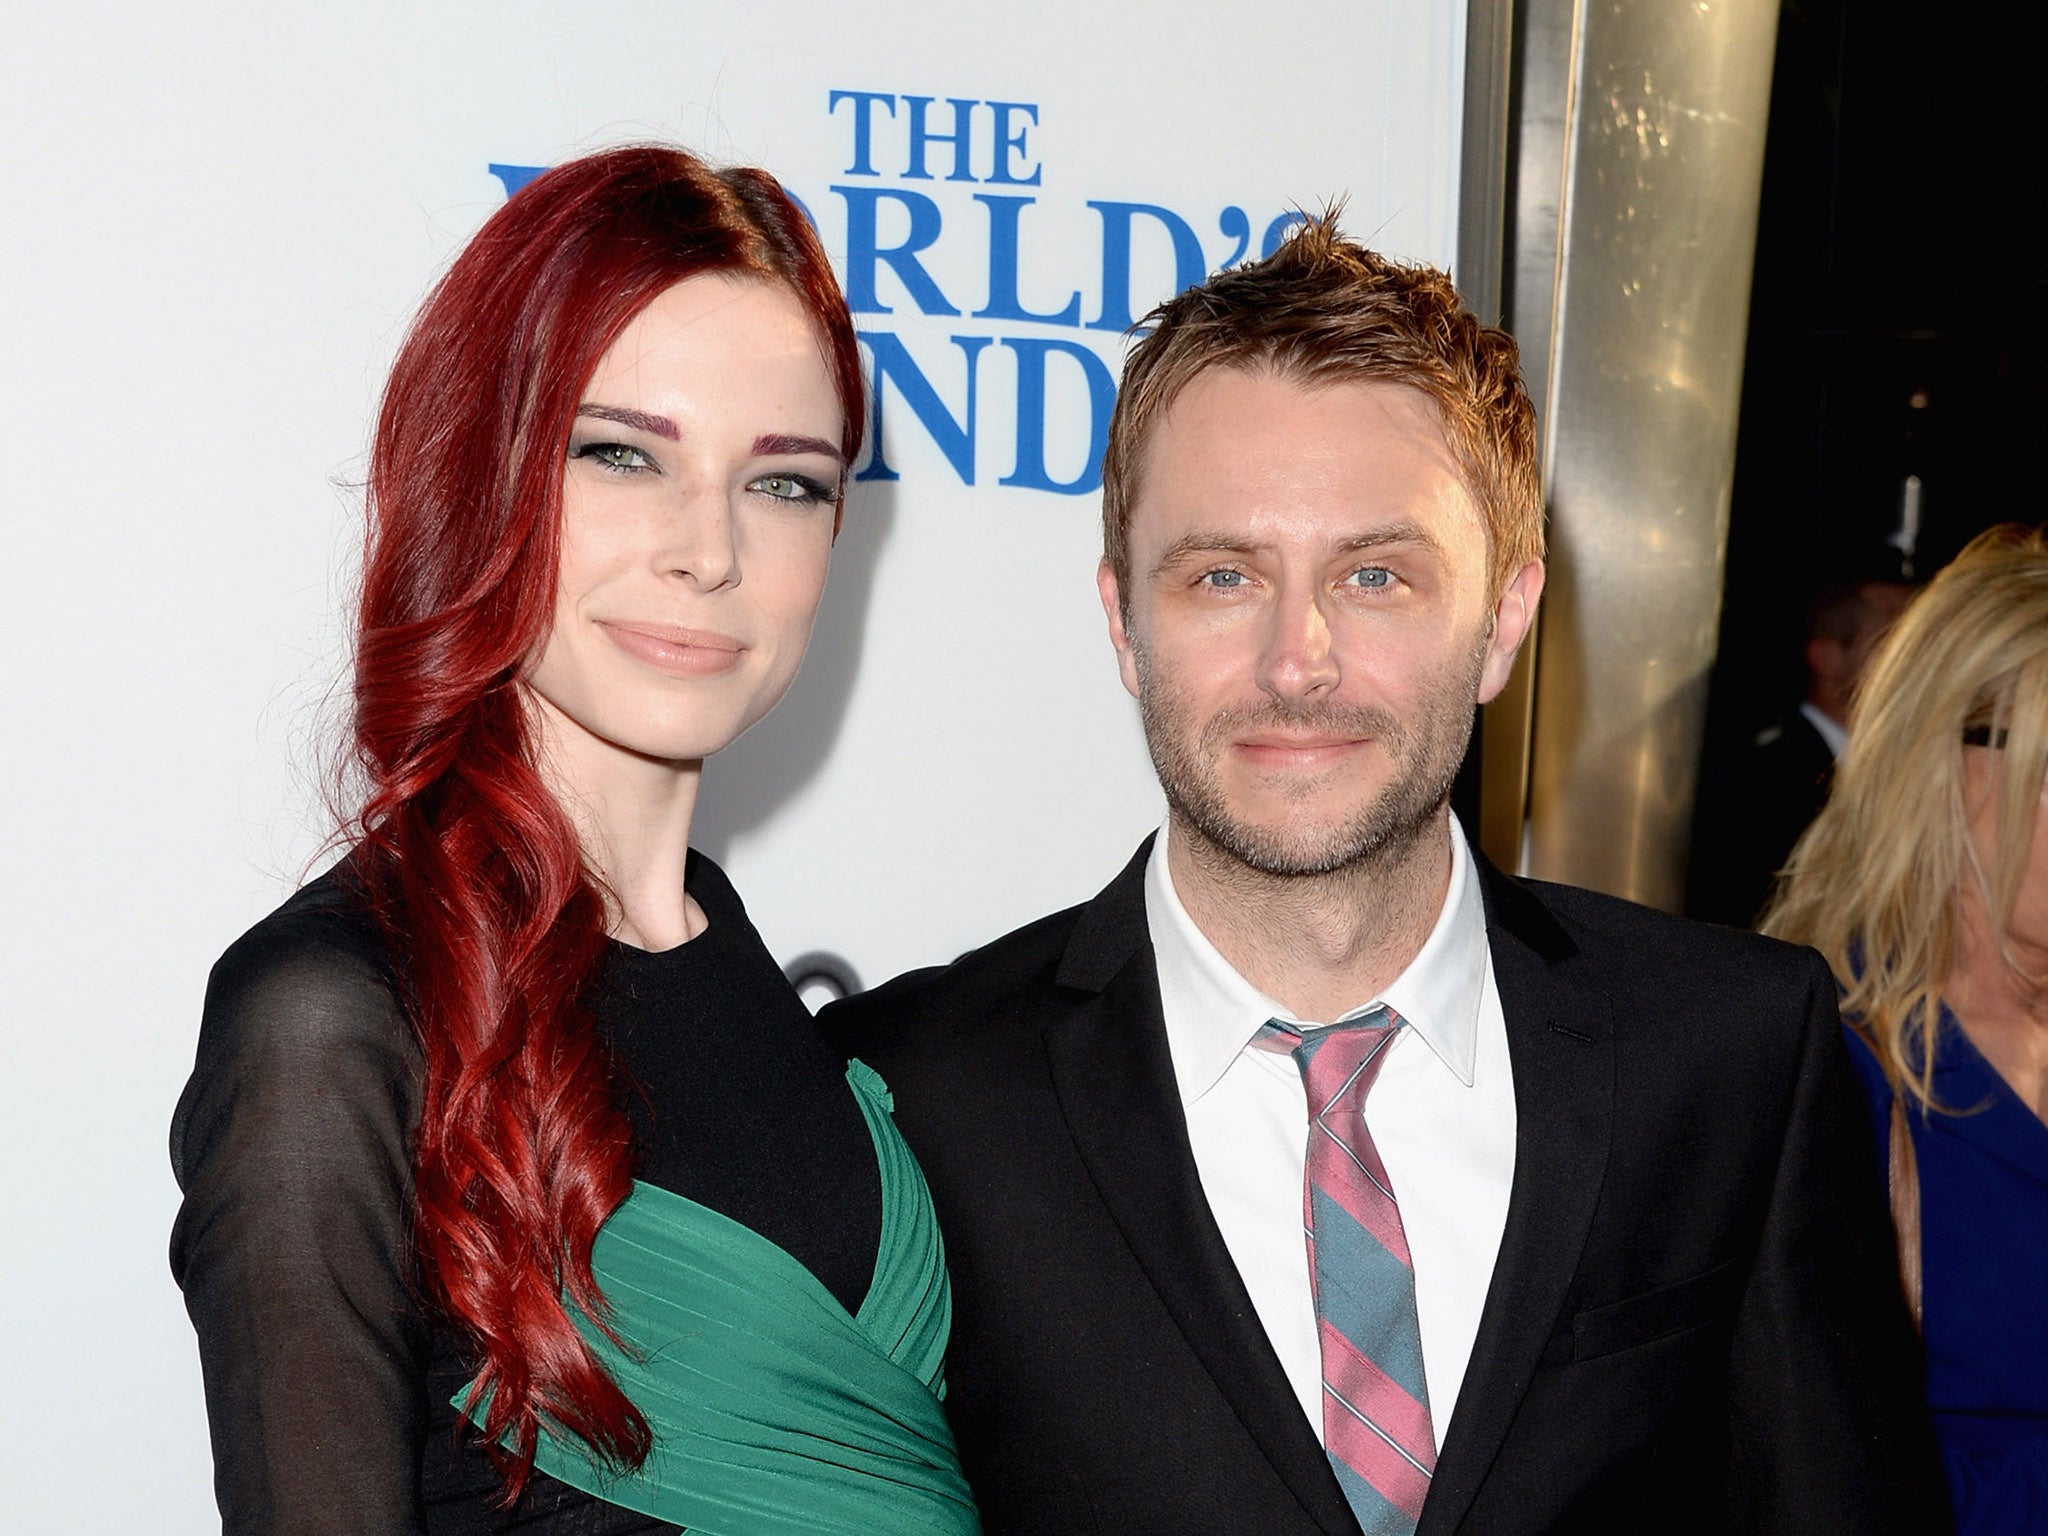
[[528, 694, 705, 950]]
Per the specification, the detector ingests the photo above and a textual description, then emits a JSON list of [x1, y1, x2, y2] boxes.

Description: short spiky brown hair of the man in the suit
[[1102, 209, 1544, 608]]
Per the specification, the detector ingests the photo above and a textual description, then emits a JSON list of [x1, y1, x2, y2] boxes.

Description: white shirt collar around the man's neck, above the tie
[[1145, 817, 1487, 1104]]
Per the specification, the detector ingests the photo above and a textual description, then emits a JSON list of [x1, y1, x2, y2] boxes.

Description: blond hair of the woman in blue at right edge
[[1761, 524, 2048, 1108]]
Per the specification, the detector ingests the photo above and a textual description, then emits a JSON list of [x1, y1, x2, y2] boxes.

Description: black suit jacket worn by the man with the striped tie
[[823, 848, 1946, 1536]]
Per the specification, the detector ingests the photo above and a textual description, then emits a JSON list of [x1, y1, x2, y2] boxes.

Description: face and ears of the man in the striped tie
[[1100, 369, 1542, 874]]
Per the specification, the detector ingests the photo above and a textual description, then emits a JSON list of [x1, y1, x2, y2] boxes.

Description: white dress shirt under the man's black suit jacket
[[1145, 817, 1516, 1446]]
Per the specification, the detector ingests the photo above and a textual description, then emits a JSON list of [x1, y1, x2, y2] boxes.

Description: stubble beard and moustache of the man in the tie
[[1133, 627, 1493, 877]]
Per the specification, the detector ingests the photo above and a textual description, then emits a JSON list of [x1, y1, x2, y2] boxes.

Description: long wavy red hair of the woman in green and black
[[352, 145, 864, 1501]]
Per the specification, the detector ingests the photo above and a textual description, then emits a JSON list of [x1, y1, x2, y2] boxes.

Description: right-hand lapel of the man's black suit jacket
[[1417, 858, 1614, 1536]]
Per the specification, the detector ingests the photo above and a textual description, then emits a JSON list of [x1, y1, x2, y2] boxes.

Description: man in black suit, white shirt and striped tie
[[825, 219, 1944, 1536]]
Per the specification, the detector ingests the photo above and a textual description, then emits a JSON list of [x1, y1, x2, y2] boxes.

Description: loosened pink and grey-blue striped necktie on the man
[[1257, 1008, 1436, 1536]]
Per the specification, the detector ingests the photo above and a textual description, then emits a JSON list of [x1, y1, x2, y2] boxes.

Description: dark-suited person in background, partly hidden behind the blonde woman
[[1686, 580, 1913, 928]]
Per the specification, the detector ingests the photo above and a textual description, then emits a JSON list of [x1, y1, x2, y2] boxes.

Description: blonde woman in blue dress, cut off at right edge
[[1763, 526, 2048, 1536]]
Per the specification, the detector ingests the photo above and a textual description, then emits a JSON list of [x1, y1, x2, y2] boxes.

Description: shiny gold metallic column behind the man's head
[[1466, 0, 1778, 907]]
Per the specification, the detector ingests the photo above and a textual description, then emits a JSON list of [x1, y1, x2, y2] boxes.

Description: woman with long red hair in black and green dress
[[172, 147, 977, 1536]]
